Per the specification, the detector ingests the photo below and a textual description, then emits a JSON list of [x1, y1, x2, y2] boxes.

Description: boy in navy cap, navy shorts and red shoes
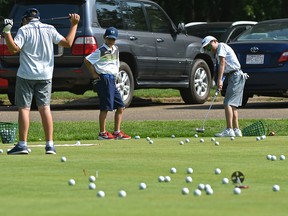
[[84, 27, 131, 140]]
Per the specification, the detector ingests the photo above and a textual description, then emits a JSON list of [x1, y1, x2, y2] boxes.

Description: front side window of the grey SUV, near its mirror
[[144, 4, 171, 33]]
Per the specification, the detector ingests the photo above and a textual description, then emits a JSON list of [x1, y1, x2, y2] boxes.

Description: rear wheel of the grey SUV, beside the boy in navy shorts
[[116, 62, 134, 107]]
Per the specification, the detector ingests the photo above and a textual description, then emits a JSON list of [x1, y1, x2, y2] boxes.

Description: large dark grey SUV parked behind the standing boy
[[0, 0, 214, 106]]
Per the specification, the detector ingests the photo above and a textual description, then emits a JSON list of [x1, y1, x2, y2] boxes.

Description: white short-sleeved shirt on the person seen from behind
[[14, 19, 64, 80]]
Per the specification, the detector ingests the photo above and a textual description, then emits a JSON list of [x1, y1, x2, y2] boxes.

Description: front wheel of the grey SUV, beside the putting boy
[[180, 59, 211, 104]]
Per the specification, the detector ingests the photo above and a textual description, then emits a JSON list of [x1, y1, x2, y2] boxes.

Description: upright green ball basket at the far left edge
[[0, 122, 18, 143]]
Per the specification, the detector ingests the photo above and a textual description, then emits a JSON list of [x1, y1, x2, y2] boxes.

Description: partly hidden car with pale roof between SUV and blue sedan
[[185, 21, 257, 43]]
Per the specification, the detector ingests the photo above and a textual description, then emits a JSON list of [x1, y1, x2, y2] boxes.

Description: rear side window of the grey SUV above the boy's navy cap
[[96, 0, 148, 31]]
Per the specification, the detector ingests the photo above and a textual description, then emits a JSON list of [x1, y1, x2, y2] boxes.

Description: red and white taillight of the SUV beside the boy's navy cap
[[72, 36, 98, 56]]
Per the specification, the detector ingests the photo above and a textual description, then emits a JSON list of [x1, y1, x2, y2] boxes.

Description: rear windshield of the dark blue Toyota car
[[236, 21, 288, 41]]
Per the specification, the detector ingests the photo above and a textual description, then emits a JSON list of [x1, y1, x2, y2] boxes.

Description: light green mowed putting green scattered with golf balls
[[0, 137, 288, 216]]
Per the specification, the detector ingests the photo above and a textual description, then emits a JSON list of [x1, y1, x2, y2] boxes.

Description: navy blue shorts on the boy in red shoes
[[96, 74, 125, 111]]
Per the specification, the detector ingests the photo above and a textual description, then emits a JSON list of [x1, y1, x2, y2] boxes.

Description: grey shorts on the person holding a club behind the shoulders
[[15, 76, 52, 108]]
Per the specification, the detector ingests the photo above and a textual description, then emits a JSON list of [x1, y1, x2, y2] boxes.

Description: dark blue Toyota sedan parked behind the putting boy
[[223, 19, 288, 105]]
